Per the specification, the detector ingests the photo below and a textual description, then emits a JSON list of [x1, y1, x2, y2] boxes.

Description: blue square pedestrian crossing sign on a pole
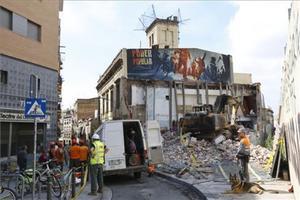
[[25, 98, 46, 118]]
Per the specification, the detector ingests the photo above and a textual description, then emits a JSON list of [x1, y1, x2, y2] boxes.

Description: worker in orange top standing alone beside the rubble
[[236, 128, 251, 182]]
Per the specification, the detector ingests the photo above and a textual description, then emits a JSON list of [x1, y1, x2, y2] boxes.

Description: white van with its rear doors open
[[95, 120, 163, 178]]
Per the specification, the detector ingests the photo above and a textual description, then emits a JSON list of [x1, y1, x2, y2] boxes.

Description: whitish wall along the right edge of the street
[[279, 1, 300, 200]]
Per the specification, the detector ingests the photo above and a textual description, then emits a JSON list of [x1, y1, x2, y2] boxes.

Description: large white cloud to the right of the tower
[[228, 2, 290, 111]]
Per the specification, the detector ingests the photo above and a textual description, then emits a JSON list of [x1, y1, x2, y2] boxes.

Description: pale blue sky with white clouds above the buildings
[[60, 1, 290, 112]]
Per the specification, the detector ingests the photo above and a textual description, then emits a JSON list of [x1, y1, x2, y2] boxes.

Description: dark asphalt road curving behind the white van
[[105, 174, 204, 200]]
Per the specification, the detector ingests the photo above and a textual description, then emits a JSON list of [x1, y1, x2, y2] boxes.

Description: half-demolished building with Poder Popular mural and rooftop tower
[[96, 19, 272, 143]]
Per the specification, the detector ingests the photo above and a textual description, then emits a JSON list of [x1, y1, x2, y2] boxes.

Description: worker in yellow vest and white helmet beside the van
[[89, 133, 107, 196]]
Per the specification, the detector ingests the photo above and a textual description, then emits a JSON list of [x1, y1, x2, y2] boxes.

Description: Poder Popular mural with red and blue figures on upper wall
[[127, 49, 232, 82]]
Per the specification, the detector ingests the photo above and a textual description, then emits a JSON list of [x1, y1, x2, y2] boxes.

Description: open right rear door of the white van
[[146, 121, 163, 164]]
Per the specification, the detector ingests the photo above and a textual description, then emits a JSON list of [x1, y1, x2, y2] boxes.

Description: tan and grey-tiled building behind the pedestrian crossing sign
[[0, 0, 63, 156]]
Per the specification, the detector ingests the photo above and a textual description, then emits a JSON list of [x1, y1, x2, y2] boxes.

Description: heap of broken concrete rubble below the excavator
[[160, 132, 271, 179]]
